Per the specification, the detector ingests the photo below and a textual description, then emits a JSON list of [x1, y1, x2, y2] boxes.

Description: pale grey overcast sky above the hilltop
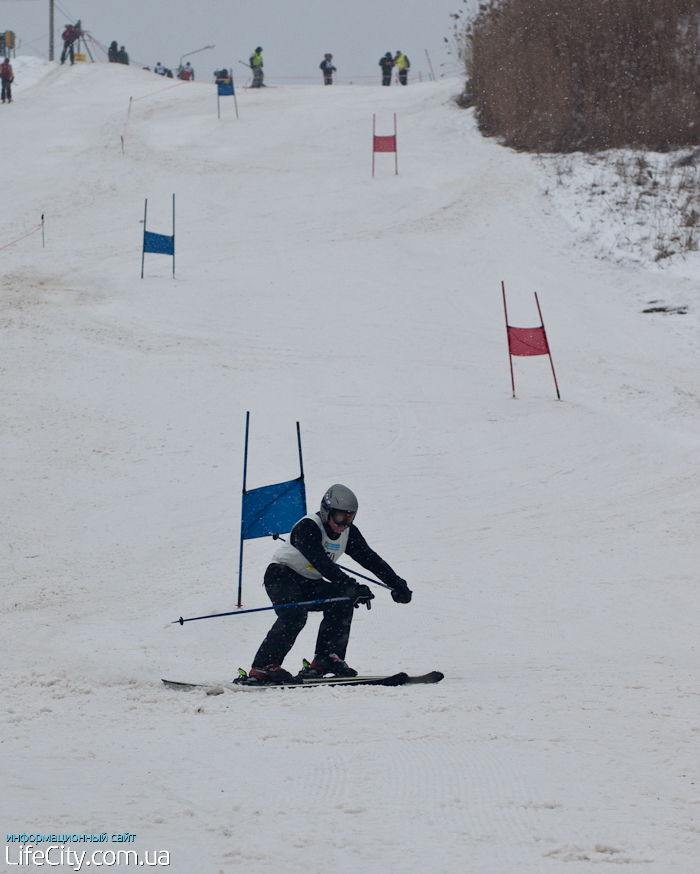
[[0, 0, 471, 82]]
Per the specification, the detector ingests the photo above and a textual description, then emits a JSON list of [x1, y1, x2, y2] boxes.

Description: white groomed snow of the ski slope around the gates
[[0, 59, 700, 874]]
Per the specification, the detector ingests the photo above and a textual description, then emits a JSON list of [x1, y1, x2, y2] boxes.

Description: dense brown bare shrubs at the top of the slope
[[456, 0, 700, 152]]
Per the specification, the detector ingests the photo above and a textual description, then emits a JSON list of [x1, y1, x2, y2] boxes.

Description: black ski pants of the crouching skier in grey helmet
[[253, 562, 354, 668]]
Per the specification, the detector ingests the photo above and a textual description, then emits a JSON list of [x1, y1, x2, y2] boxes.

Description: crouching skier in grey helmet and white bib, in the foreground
[[248, 484, 412, 684]]
